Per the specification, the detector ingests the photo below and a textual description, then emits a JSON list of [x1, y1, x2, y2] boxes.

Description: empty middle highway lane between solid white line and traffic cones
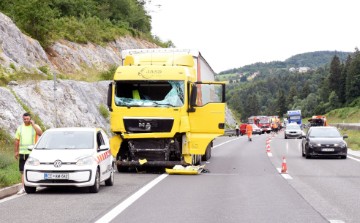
[[101, 135, 327, 223]]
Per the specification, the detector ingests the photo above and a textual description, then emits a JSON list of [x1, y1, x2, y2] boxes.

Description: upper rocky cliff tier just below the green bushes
[[0, 13, 158, 74]]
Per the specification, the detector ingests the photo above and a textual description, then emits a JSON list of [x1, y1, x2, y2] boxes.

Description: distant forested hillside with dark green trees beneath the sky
[[225, 49, 360, 121]]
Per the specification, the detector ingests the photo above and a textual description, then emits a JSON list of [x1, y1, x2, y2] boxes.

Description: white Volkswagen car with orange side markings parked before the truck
[[24, 127, 114, 193]]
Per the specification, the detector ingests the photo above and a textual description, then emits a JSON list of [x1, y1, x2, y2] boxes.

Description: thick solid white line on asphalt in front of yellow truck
[[96, 174, 168, 223]]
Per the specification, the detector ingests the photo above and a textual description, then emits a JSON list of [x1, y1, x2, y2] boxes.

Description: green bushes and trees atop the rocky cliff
[[0, 0, 172, 48]]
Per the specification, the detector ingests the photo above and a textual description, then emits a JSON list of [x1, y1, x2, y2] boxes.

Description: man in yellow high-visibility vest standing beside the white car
[[15, 113, 42, 194]]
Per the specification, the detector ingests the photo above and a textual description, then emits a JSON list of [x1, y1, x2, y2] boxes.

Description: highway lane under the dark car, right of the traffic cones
[[270, 133, 360, 222]]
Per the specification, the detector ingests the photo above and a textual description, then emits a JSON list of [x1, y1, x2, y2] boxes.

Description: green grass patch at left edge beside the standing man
[[0, 129, 21, 188]]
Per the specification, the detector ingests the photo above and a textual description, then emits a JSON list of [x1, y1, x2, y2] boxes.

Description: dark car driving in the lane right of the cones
[[302, 126, 348, 159]]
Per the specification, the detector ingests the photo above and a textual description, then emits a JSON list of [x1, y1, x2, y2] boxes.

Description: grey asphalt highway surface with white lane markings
[[0, 133, 360, 223]]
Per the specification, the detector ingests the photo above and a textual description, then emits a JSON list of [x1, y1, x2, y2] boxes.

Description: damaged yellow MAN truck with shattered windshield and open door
[[107, 48, 225, 172]]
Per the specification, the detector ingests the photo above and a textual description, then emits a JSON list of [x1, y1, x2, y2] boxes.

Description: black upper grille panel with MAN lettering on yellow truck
[[124, 118, 174, 133]]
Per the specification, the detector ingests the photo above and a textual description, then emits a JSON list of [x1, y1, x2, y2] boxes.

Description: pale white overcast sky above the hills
[[146, 0, 360, 73]]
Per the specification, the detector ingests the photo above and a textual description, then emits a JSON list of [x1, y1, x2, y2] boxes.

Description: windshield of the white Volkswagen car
[[35, 131, 94, 149]]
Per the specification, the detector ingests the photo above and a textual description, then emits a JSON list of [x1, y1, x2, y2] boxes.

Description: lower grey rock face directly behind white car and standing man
[[0, 80, 110, 135]]
